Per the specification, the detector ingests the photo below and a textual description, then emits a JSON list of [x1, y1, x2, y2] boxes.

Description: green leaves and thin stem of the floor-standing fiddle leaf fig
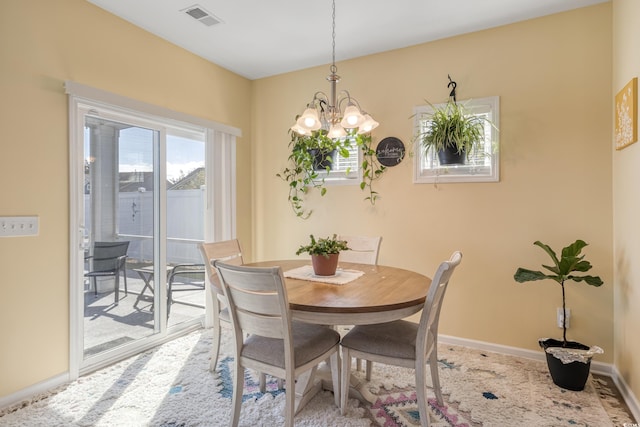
[[513, 240, 603, 347]]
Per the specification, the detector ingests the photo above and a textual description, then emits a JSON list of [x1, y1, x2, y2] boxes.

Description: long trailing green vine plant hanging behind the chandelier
[[277, 130, 386, 219]]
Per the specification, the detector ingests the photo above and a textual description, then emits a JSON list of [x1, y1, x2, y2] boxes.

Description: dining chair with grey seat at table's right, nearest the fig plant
[[340, 251, 462, 427]]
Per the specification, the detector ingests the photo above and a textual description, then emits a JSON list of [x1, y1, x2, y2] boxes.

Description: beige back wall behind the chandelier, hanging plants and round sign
[[252, 4, 614, 362]]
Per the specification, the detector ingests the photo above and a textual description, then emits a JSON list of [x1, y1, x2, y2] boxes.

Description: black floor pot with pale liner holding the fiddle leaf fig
[[538, 338, 591, 391]]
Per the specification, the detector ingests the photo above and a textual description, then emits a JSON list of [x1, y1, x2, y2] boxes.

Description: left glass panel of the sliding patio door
[[83, 118, 160, 359]]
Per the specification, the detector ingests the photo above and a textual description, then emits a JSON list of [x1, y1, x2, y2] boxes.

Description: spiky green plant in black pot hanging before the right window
[[416, 98, 493, 165]]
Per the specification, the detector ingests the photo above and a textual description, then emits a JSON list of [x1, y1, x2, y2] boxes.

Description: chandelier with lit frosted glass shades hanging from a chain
[[291, 0, 379, 139]]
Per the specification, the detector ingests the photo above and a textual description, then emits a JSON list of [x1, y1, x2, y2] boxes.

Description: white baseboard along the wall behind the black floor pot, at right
[[438, 335, 640, 420]]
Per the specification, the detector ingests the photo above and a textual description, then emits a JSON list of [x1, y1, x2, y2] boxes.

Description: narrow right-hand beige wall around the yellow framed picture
[[612, 0, 640, 406]]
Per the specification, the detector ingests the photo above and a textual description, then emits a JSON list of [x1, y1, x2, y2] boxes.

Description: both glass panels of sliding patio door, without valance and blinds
[[77, 101, 207, 370]]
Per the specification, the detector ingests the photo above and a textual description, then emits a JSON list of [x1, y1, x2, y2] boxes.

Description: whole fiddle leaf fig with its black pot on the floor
[[513, 240, 603, 391]]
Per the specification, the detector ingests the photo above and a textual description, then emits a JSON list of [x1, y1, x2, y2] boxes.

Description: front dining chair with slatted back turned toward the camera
[[214, 261, 340, 426]]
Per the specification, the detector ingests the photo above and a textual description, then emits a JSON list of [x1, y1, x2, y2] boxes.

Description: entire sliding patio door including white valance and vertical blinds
[[65, 82, 240, 378]]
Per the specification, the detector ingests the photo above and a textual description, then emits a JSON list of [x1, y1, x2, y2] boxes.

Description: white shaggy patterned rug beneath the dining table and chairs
[[0, 329, 633, 427]]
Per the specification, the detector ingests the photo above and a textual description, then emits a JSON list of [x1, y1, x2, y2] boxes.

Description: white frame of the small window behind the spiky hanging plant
[[413, 96, 500, 184]]
